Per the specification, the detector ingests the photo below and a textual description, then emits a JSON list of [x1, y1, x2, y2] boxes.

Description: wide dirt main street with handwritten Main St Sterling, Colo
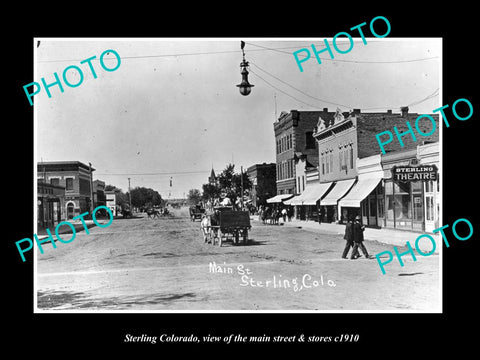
[[37, 209, 441, 312]]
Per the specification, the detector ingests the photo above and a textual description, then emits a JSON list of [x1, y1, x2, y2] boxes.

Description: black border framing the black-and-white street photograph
[[6, 2, 480, 357]]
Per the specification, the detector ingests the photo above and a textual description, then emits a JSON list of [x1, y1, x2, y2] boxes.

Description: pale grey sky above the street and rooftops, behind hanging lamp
[[34, 38, 442, 198]]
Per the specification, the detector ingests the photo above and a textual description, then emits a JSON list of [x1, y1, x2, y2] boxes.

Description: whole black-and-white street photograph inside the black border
[[34, 37, 442, 313]]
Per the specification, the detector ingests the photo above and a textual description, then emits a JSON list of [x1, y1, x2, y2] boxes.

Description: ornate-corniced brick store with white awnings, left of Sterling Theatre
[[313, 107, 439, 231]]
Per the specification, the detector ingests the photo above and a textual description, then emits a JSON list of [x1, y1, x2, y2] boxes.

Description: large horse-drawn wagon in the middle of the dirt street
[[202, 207, 251, 246]]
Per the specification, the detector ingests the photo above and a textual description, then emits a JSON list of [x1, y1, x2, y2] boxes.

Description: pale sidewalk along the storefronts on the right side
[[253, 215, 442, 254]]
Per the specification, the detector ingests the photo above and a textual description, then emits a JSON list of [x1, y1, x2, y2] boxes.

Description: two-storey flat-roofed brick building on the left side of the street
[[37, 161, 95, 219]]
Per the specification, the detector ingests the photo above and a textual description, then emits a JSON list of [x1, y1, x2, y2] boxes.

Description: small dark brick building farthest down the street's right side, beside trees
[[247, 163, 277, 207]]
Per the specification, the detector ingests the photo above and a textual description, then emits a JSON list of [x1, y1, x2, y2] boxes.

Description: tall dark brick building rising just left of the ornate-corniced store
[[273, 108, 335, 194]]
